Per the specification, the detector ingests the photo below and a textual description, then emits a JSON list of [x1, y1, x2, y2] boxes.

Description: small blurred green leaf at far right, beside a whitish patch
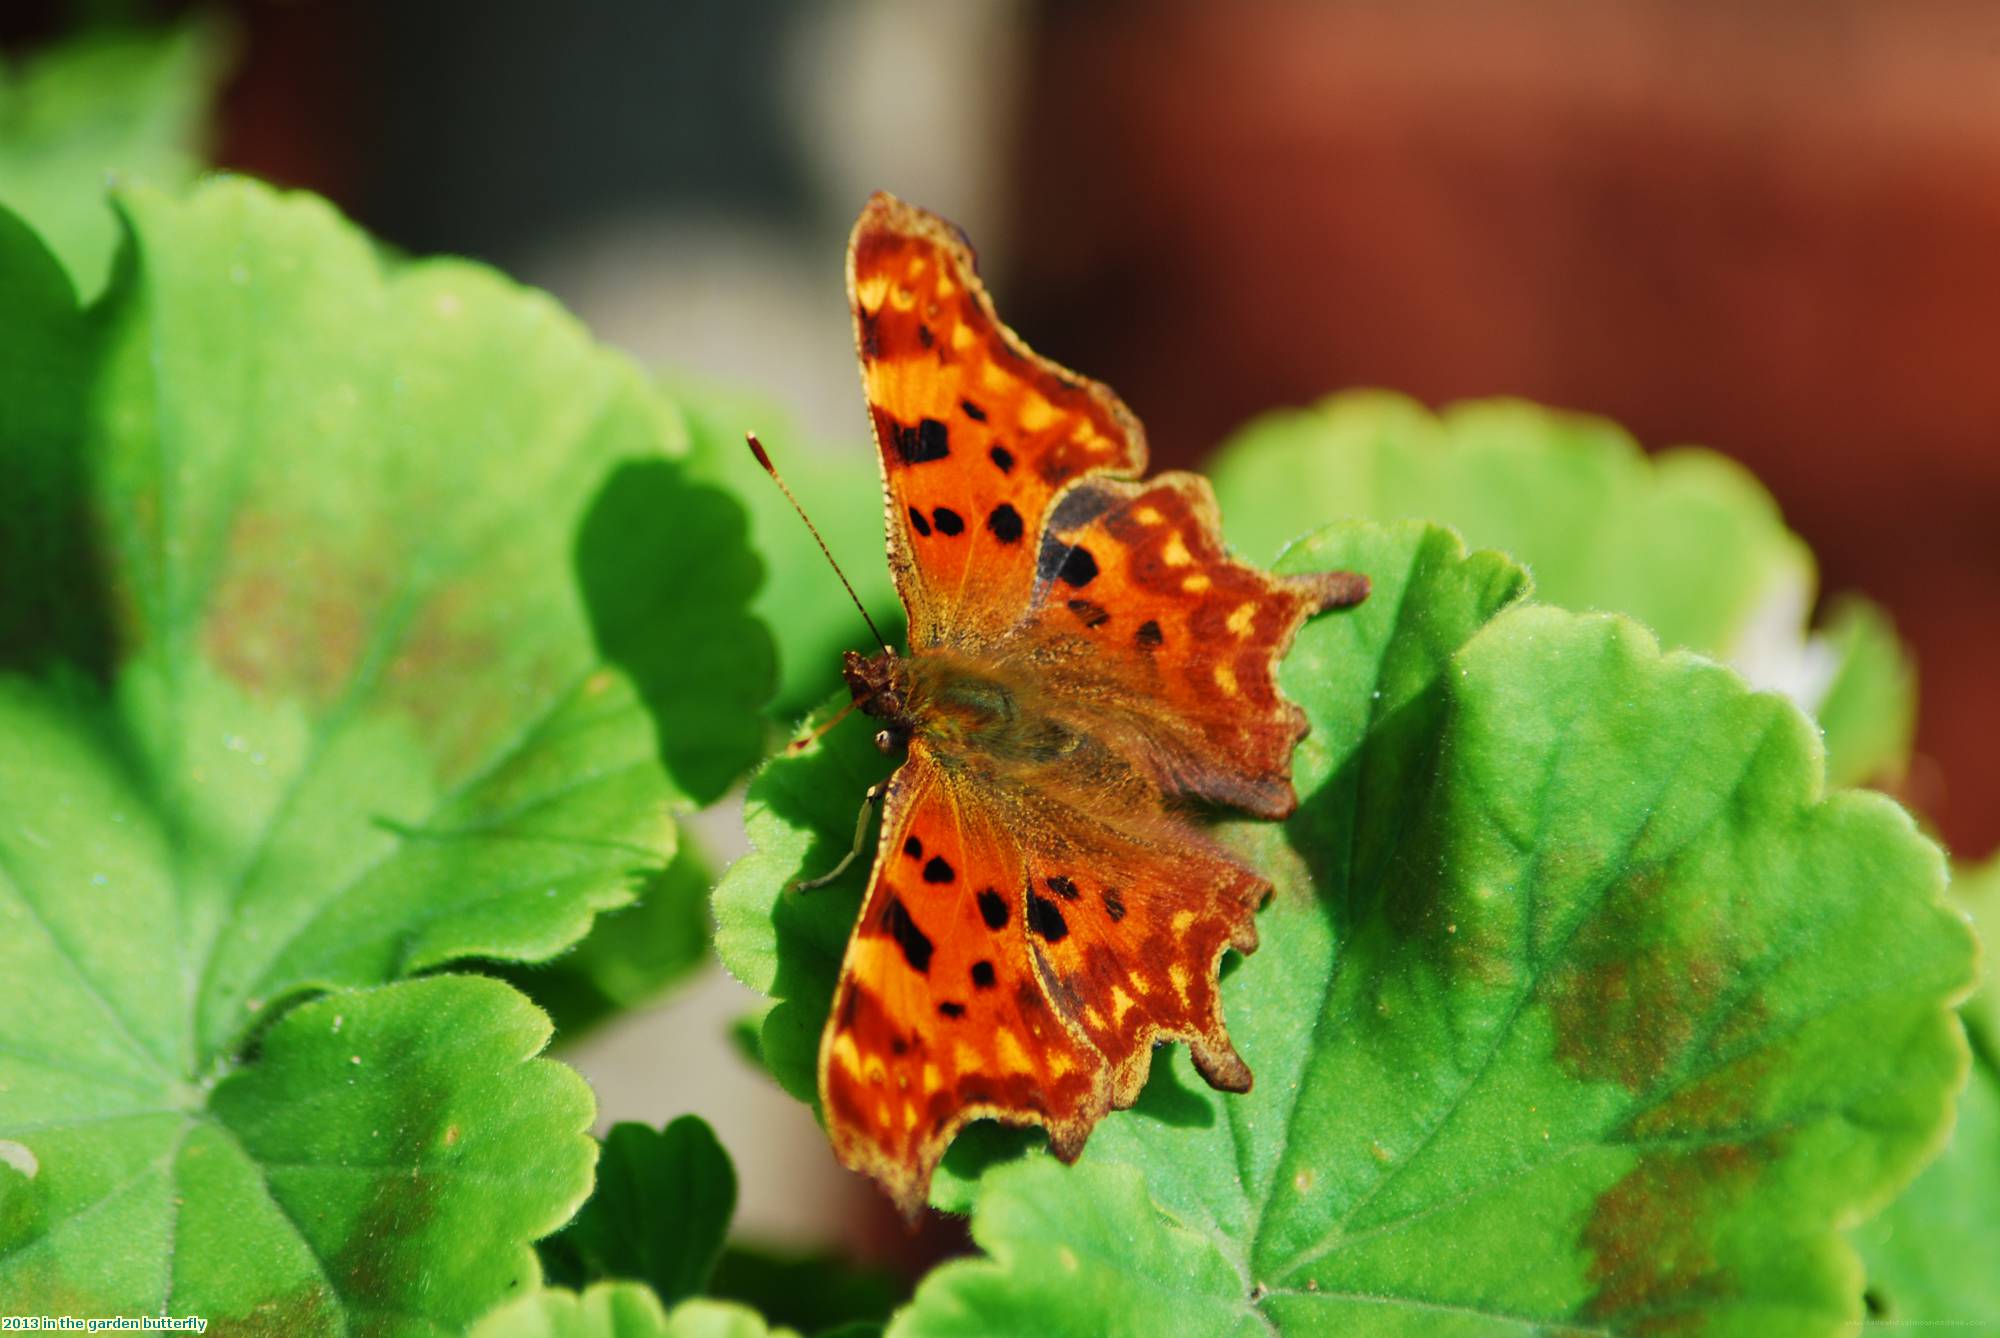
[[1812, 598, 1916, 786]]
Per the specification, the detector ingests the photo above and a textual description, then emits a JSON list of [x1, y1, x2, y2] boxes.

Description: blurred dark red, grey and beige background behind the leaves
[[11, 0, 2000, 1296]]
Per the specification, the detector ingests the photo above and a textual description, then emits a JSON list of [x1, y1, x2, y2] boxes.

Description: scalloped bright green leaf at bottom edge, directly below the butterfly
[[888, 1158, 1270, 1338]]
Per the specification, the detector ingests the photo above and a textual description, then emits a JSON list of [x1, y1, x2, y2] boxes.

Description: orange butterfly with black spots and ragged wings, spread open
[[818, 194, 1368, 1218]]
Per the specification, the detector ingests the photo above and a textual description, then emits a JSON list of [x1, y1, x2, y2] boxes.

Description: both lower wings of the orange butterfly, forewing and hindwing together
[[820, 744, 1270, 1216]]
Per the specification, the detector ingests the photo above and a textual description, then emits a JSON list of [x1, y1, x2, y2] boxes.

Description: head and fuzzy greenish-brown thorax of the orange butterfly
[[842, 650, 1084, 762]]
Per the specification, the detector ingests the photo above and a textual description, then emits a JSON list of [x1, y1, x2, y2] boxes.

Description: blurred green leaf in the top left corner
[[0, 22, 230, 294]]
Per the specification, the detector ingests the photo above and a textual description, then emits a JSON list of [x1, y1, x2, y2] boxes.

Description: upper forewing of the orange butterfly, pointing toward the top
[[848, 194, 1146, 650]]
